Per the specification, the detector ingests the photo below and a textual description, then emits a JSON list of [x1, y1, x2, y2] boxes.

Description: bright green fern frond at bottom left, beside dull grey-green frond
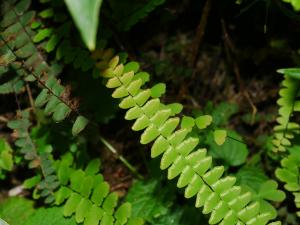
[[55, 154, 143, 225]]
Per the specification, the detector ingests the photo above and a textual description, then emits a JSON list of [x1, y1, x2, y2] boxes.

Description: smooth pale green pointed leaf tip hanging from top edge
[[65, 0, 102, 50]]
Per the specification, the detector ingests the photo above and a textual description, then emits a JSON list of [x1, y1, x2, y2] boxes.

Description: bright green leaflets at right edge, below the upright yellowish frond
[[275, 152, 300, 217]]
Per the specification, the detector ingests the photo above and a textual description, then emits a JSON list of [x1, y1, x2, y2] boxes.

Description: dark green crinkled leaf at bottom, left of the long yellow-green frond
[[126, 177, 207, 225]]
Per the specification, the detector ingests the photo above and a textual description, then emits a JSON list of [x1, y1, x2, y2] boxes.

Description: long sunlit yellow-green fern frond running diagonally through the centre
[[98, 51, 282, 225]]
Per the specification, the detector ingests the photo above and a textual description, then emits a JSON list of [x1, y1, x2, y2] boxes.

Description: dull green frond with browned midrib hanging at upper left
[[0, 0, 88, 135]]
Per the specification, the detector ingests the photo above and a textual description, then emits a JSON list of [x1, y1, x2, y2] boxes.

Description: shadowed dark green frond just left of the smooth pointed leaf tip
[[31, 1, 94, 71]]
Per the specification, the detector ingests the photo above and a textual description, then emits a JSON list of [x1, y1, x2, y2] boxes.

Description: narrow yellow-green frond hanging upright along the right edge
[[272, 70, 300, 152]]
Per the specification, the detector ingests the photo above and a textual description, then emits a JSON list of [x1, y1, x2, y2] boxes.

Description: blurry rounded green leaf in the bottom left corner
[[0, 197, 34, 225]]
